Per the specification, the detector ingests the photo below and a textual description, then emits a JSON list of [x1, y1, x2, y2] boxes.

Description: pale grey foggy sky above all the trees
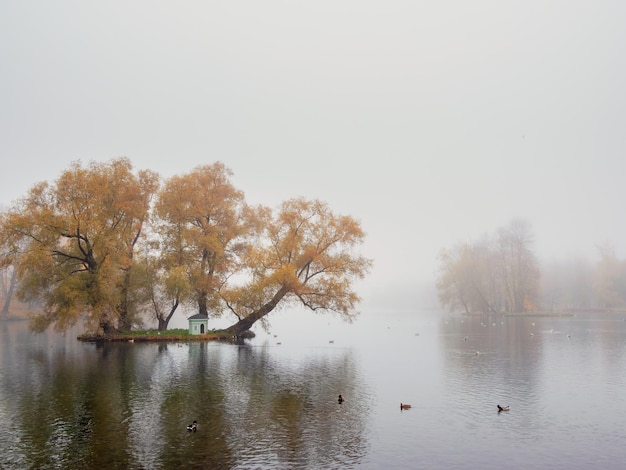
[[0, 0, 626, 304]]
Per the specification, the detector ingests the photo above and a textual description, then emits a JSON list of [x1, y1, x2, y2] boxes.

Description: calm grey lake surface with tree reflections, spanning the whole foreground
[[0, 310, 626, 469]]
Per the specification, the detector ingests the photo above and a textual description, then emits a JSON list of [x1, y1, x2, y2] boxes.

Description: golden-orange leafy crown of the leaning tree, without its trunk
[[223, 198, 371, 316]]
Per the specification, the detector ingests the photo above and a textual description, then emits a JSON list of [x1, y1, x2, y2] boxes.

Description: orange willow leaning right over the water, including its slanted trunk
[[220, 199, 371, 336]]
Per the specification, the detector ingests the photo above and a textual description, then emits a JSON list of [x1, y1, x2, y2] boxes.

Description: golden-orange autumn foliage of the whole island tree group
[[0, 158, 371, 336]]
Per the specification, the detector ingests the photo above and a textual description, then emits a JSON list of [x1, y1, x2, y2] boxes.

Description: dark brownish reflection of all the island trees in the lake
[[0, 324, 371, 468]]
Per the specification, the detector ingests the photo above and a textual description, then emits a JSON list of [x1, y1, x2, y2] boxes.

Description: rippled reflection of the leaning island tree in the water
[[224, 346, 370, 468]]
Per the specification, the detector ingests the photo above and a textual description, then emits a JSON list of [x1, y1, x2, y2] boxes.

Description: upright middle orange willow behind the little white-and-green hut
[[155, 162, 256, 322]]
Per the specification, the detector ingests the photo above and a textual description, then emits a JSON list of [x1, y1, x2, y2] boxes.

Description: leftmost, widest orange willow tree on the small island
[[1, 158, 159, 333]]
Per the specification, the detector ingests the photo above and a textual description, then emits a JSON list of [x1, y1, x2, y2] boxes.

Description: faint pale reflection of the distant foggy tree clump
[[440, 316, 543, 441]]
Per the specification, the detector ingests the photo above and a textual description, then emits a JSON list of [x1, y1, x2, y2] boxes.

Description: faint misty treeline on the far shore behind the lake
[[437, 219, 626, 313]]
